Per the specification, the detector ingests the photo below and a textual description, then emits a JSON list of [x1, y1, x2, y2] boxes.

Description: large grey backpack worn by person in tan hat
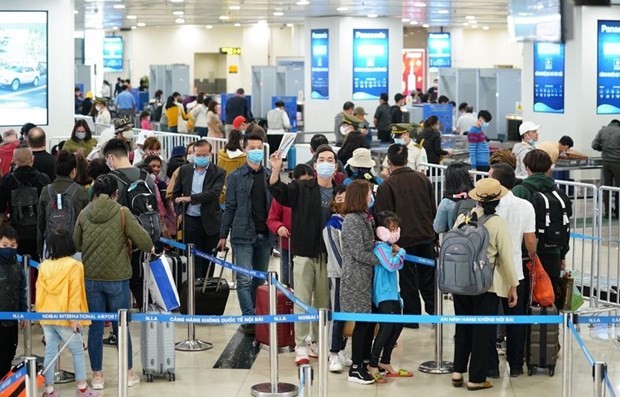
[[437, 215, 496, 295]]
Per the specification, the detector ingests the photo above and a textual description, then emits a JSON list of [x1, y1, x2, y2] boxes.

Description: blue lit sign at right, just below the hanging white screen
[[534, 43, 564, 113]]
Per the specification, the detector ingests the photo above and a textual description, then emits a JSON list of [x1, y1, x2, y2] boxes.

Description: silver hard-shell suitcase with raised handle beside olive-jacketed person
[[140, 257, 176, 382]]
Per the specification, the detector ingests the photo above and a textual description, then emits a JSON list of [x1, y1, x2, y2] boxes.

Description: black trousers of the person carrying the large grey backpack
[[453, 292, 499, 383]]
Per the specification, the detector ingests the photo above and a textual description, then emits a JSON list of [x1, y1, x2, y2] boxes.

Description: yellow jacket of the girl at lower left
[[35, 257, 90, 327]]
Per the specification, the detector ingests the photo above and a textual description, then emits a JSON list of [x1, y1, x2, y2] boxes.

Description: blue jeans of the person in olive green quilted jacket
[[86, 279, 133, 372]]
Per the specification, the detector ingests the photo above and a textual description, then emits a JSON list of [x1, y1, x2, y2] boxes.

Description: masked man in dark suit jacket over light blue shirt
[[172, 140, 226, 277]]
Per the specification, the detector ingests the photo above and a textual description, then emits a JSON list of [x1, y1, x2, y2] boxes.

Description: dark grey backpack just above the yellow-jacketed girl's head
[[45, 182, 80, 256]]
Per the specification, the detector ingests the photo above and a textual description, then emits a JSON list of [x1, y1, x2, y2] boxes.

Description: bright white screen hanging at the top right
[[508, 0, 563, 43]]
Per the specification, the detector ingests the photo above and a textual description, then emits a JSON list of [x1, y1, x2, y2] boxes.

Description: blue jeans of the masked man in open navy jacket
[[233, 234, 271, 316]]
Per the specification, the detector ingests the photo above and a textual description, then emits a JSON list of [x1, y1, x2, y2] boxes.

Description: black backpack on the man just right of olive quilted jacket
[[110, 170, 161, 243]]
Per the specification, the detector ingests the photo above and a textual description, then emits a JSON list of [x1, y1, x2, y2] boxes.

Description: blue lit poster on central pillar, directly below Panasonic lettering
[[353, 29, 389, 100]]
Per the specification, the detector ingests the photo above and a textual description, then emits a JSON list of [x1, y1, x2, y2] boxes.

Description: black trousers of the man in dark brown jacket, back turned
[[399, 243, 435, 315]]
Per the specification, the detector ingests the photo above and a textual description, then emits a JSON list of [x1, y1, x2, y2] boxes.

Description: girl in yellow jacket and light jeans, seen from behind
[[36, 231, 99, 397]]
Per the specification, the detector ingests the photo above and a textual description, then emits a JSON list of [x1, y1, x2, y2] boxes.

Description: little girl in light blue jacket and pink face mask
[[368, 211, 413, 383]]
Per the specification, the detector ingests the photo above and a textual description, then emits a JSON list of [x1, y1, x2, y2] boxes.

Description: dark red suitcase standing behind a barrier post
[[255, 285, 295, 351]]
